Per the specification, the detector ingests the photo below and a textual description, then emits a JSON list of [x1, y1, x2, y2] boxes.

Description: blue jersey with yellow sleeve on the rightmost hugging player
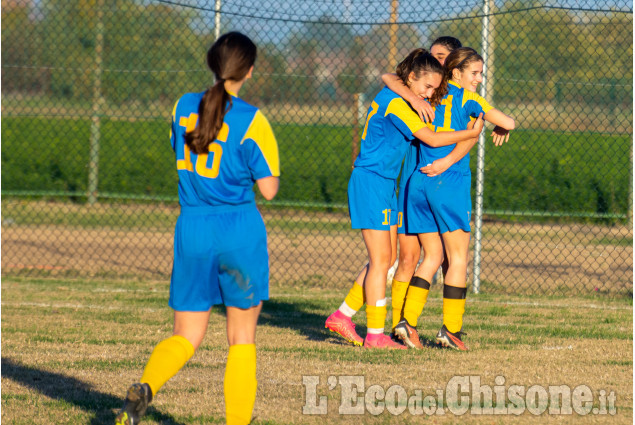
[[418, 81, 492, 173]]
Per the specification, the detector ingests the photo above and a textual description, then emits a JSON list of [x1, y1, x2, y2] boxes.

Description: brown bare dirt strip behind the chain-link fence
[[2, 214, 633, 294]]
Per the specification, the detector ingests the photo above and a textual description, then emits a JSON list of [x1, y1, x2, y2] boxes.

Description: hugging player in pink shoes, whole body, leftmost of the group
[[325, 49, 482, 348]]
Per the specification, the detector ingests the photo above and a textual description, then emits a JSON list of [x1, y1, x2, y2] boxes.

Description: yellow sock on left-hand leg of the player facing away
[[140, 335, 194, 396]]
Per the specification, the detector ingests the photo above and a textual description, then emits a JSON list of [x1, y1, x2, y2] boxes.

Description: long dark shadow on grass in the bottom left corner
[[2, 357, 184, 425]]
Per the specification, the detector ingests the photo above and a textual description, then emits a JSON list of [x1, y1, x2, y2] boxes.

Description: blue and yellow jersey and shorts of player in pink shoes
[[348, 87, 425, 230]]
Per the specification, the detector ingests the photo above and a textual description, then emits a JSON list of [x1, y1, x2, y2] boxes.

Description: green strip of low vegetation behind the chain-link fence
[[2, 117, 631, 219]]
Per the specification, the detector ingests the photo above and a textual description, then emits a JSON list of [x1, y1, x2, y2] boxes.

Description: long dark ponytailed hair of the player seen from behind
[[185, 32, 257, 154]]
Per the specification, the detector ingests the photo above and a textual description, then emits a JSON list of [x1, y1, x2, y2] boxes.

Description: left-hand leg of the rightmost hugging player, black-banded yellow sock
[[395, 233, 443, 348]]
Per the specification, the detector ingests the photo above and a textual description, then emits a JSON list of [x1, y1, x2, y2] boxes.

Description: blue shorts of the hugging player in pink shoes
[[348, 168, 397, 230]]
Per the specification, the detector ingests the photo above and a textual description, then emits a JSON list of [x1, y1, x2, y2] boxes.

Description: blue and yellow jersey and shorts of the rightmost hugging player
[[407, 81, 492, 233]]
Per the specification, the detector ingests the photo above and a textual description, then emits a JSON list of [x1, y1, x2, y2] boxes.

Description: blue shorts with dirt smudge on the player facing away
[[169, 204, 269, 311]]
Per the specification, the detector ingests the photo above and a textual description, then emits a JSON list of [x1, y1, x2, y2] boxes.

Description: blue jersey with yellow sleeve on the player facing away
[[170, 92, 280, 207]]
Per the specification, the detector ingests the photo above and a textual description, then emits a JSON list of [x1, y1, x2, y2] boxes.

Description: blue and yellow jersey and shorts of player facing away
[[169, 93, 280, 311]]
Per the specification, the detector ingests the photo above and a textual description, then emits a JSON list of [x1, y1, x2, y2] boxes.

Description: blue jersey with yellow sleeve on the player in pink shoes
[[354, 87, 425, 179]]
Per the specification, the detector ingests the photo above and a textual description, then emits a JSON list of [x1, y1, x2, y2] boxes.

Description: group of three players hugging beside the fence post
[[325, 37, 515, 350]]
